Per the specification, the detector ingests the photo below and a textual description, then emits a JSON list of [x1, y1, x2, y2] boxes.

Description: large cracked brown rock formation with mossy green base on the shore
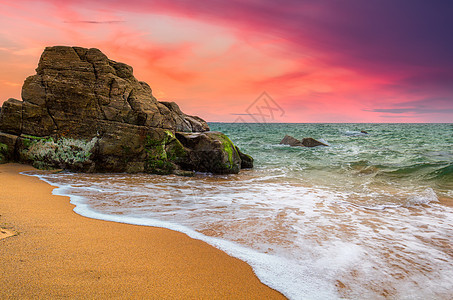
[[0, 46, 253, 174]]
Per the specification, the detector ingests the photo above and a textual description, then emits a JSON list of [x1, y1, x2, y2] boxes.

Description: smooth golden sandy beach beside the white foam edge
[[0, 164, 284, 299]]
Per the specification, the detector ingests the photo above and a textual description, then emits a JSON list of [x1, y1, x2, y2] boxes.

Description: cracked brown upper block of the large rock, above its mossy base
[[16, 46, 209, 137]]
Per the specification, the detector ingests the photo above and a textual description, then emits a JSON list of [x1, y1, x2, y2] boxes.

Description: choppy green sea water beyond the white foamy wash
[[210, 123, 453, 205]]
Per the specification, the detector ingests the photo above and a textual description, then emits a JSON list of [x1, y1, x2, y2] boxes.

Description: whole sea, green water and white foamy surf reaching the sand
[[28, 123, 453, 299]]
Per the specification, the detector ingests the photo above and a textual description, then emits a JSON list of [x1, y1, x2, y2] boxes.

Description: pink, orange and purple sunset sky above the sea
[[0, 0, 453, 123]]
